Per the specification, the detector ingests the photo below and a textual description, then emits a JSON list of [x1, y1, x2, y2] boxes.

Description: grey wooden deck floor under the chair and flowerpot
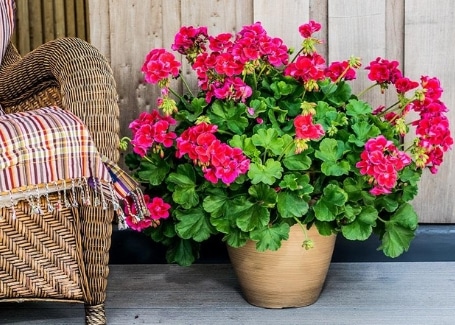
[[0, 262, 455, 325]]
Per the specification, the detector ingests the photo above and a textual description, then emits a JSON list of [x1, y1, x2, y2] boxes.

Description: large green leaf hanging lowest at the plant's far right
[[379, 203, 418, 257]]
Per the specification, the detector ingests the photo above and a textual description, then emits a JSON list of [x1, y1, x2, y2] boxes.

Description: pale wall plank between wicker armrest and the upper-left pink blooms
[[108, 0, 167, 134]]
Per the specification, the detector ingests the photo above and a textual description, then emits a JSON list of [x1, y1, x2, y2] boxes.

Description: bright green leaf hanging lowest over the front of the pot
[[250, 223, 289, 252]]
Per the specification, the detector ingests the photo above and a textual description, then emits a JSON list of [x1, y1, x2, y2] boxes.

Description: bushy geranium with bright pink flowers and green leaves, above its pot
[[119, 21, 453, 306]]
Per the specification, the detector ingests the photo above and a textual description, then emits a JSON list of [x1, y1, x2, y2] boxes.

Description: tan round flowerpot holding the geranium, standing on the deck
[[228, 224, 336, 308]]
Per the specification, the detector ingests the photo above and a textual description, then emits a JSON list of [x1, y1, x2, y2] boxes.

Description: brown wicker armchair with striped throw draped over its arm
[[0, 38, 119, 324]]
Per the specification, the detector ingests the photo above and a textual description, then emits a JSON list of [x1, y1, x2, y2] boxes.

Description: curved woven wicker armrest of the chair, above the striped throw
[[0, 38, 119, 162]]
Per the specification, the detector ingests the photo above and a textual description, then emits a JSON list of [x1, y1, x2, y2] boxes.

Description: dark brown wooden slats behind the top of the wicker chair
[[13, 0, 90, 54]]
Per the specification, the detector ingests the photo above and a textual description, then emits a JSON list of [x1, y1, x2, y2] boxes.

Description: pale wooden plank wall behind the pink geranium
[[89, 0, 455, 223]]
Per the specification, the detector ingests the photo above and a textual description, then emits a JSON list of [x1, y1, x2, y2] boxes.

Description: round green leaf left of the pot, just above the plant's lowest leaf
[[174, 208, 214, 242]]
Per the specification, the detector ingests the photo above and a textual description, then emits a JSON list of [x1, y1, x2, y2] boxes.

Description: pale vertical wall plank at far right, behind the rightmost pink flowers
[[404, 0, 455, 223]]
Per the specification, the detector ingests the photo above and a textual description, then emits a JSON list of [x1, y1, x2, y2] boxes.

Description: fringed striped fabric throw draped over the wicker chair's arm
[[0, 107, 147, 224]]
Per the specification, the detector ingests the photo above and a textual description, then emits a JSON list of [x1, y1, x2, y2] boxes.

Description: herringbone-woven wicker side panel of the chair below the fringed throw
[[0, 194, 83, 300]]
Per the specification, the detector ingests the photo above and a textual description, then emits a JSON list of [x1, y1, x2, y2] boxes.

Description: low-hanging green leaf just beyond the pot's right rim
[[341, 206, 378, 240]]
